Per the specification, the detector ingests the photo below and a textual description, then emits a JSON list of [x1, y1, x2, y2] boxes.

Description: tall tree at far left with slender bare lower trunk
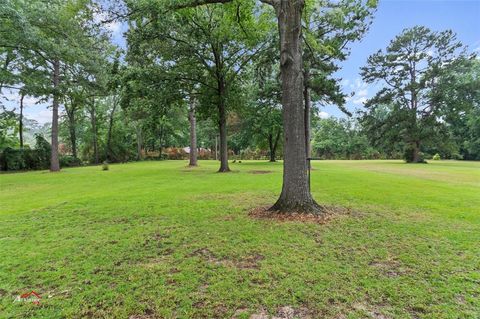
[[0, 0, 112, 171]]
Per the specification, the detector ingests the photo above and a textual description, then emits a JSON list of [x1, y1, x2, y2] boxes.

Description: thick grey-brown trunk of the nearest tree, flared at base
[[271, 0, 321, 213]]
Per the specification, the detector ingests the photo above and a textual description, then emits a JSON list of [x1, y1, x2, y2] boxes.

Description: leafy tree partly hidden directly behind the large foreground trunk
[[303, 0, 377, 157]]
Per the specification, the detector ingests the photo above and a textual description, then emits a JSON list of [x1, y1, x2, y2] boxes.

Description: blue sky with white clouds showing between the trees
[[4, 0, 480, 123]]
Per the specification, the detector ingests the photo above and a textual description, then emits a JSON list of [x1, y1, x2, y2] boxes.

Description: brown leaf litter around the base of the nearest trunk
[[248, 205, 354, 224]]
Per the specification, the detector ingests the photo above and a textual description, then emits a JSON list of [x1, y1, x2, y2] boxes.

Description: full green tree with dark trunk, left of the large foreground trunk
[[125, 2, 270, 172]]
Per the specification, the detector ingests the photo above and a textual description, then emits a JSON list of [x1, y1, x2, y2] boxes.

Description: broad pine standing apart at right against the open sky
[[361, 26, 466, 163]]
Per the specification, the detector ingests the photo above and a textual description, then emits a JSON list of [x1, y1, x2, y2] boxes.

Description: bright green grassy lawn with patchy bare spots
[[0, 161, 480, 319]]
